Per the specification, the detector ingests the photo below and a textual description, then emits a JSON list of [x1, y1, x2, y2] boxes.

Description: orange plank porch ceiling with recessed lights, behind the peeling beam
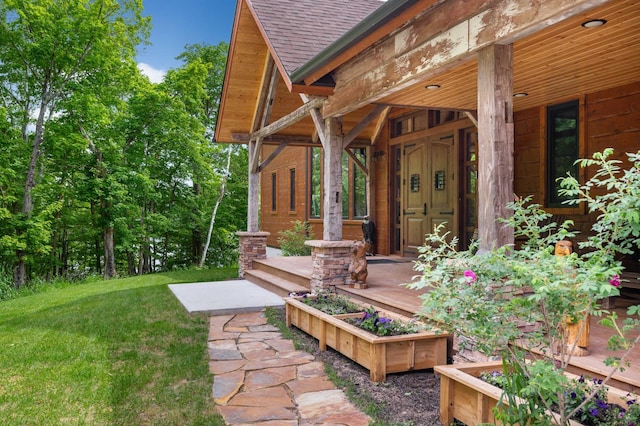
[[380, 0, 640, 111]]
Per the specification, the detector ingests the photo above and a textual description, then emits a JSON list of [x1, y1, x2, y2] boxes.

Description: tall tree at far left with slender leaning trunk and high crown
[[0, 0, 149, 286]]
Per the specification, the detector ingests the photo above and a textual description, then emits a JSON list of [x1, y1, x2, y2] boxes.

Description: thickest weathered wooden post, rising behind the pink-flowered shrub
[[478, 45, 514, 252]]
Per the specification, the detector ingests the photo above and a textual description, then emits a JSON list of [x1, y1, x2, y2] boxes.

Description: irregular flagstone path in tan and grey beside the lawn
[[208, 311, 371, 426]]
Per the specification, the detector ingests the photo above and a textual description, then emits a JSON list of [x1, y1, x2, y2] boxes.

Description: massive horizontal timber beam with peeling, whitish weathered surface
[[322, 0, 607, 118]]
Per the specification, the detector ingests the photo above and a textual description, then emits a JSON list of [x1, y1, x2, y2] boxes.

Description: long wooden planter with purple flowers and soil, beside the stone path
[[285, 294, 448, 382]]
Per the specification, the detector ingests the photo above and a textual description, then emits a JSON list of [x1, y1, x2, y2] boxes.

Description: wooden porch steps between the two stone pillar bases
[[245, 259, 311, 297]]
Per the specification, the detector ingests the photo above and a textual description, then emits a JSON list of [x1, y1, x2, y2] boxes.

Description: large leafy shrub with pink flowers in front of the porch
[[411, 150, 640, 425]]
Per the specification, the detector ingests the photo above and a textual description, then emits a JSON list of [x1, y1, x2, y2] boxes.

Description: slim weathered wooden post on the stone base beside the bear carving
[[323, 117, 343, 241]]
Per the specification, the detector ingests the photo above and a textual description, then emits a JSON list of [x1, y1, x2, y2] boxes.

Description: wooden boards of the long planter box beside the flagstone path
[[284, 298, 449, 382]]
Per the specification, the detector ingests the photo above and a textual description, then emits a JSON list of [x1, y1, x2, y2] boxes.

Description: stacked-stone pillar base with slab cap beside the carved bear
[[305, 240, 353, 292]]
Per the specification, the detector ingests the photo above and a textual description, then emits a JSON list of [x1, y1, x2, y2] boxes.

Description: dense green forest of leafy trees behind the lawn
[[0, 0, 247, 290]]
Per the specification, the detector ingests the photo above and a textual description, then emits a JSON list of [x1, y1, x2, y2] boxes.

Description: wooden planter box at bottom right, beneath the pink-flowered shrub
[[434, 361, 626, 426]]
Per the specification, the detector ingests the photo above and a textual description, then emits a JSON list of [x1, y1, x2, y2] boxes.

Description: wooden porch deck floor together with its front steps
[[245, 255, 640, 392]]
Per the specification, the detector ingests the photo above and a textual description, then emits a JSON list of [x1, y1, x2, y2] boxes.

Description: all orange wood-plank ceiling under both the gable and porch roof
[[216, 0, 640, 142]]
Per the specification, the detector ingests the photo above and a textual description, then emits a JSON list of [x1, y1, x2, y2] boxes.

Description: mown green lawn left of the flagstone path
[[0, 269, 237, 425]]
